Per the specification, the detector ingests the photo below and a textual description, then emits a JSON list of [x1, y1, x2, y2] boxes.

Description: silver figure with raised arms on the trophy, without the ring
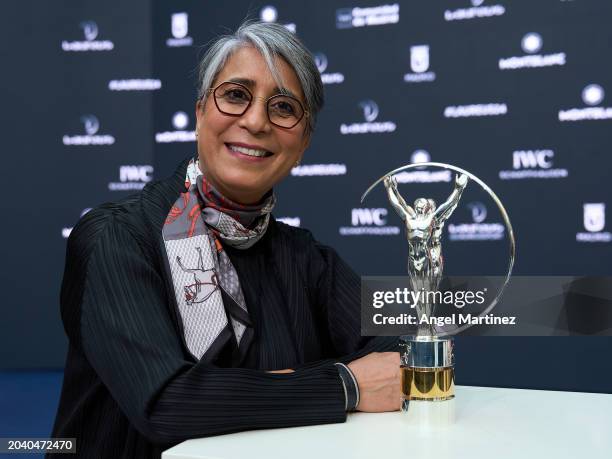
[[384, 174, 468, 338]]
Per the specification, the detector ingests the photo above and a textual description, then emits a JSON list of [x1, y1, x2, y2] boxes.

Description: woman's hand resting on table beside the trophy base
[[348, 352, 401, 413]]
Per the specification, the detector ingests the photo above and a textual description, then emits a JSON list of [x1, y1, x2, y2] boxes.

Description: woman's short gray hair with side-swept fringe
[[198, 21, 324, 132]]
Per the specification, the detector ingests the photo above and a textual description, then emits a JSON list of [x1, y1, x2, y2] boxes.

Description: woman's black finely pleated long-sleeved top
[[49, 157, 397, 459]]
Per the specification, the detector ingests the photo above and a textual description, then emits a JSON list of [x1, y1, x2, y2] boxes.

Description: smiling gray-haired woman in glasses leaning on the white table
[[53, 23, 399, 458]]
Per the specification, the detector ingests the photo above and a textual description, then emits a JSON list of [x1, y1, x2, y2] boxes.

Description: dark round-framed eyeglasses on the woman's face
[[206, 81, 308, 129]]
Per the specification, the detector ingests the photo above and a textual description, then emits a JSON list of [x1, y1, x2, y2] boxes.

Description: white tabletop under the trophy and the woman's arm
[[162, 386, 612, 459]]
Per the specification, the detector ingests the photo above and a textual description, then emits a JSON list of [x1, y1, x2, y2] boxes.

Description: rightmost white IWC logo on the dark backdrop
[[499, 149, 569, 180]]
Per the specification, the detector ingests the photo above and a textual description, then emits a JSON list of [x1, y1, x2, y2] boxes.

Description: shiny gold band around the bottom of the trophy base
[[401, 366, 455, 401]]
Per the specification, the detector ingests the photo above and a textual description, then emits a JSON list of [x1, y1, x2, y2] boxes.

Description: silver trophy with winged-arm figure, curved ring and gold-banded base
[[361, 163, 515, 427]]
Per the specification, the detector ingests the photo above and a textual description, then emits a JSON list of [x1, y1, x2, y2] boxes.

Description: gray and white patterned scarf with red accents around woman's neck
[[162, 159, 275, 362]]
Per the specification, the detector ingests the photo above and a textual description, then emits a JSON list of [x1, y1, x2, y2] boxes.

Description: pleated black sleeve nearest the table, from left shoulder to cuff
[[67, 211, 346, 443]]
